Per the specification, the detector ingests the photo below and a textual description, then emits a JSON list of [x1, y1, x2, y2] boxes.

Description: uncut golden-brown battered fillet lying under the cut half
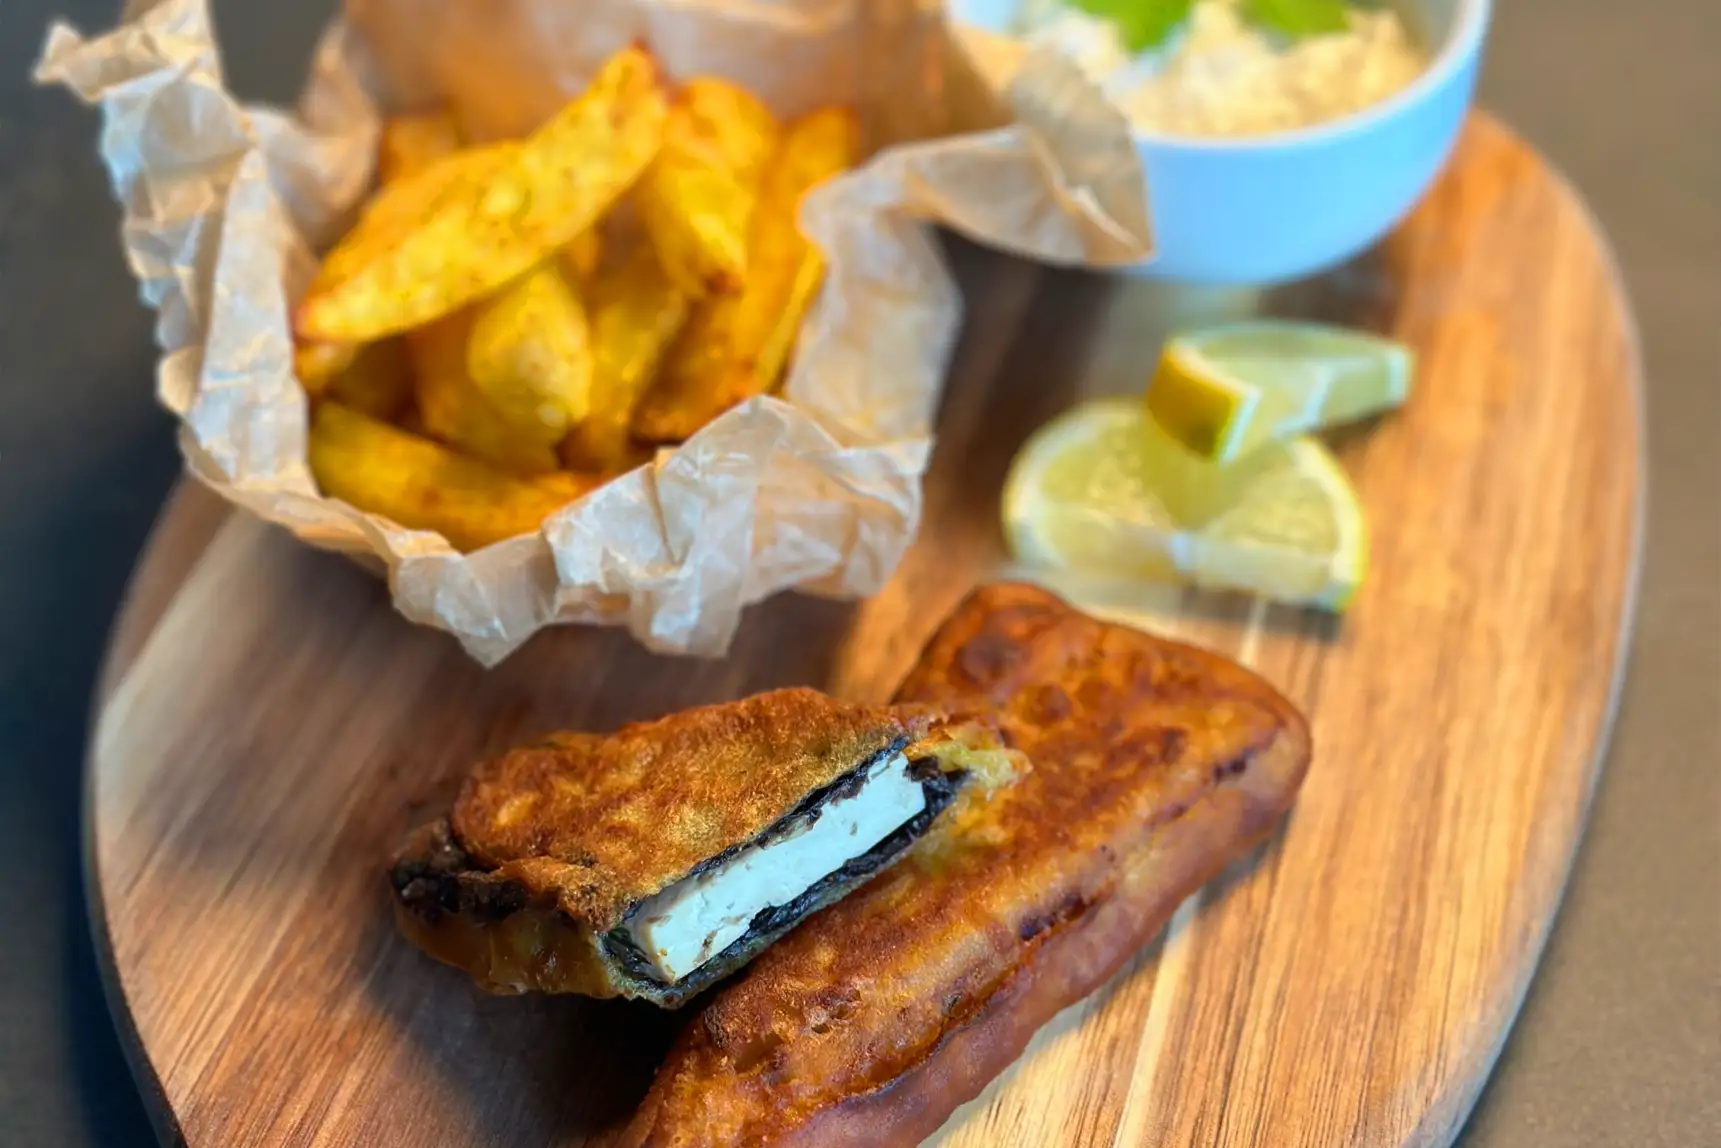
[[621, 585, 1310, 1148]]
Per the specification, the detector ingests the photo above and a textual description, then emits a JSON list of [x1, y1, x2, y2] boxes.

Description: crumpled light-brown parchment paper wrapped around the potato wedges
[[36, 0, 1151, 664]]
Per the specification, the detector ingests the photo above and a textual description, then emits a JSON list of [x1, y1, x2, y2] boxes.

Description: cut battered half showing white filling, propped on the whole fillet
[[391, 688, 1019, 1007]]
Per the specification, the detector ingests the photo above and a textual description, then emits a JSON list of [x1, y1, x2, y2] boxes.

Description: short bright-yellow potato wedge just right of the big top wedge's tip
[[635, 79, 781, 298]]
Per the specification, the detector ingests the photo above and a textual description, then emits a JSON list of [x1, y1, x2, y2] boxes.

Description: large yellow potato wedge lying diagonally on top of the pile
[[294, 48, 668, 343]]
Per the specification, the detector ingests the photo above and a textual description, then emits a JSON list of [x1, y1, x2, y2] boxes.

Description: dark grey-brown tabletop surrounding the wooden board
[[0, 0, 1721, 1148]]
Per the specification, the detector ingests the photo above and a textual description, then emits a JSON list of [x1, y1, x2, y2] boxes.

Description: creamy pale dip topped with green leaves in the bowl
[[1017, 0, 1428, 136]]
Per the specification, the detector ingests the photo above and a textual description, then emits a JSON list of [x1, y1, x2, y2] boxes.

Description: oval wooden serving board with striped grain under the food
[[88, 117, 1642, 1148]]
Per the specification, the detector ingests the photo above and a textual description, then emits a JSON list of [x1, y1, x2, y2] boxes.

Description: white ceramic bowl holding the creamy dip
[[948, 0, 1492, 286]]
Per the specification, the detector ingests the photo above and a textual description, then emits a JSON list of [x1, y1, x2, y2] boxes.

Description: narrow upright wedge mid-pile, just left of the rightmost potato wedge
[[561, 244, 690, 473]]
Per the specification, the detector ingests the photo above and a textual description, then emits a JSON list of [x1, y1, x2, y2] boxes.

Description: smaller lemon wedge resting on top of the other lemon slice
[[1146, 320, 1415, 463]]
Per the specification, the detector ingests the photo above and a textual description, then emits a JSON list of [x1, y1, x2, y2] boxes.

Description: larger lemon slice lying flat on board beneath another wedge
[[1003, 399, 1368, 611]]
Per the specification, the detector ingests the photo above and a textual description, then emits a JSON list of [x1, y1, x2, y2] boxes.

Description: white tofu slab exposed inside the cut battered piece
[[628, 754, 926, 984]]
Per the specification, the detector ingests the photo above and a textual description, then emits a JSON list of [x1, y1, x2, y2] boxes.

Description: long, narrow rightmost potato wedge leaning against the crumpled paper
[[633, 108, 861, 442]]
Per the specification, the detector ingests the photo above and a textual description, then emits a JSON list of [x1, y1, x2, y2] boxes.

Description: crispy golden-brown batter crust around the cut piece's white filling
[[391, 688, 1019, 1007]]
